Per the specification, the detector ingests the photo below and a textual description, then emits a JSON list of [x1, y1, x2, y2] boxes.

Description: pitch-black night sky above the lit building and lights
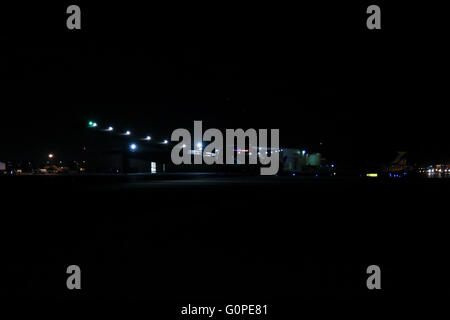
[[0, 1, 450, 163]]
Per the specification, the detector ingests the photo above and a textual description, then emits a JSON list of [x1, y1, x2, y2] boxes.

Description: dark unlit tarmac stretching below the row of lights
[[0, 175, 450, 303]]
